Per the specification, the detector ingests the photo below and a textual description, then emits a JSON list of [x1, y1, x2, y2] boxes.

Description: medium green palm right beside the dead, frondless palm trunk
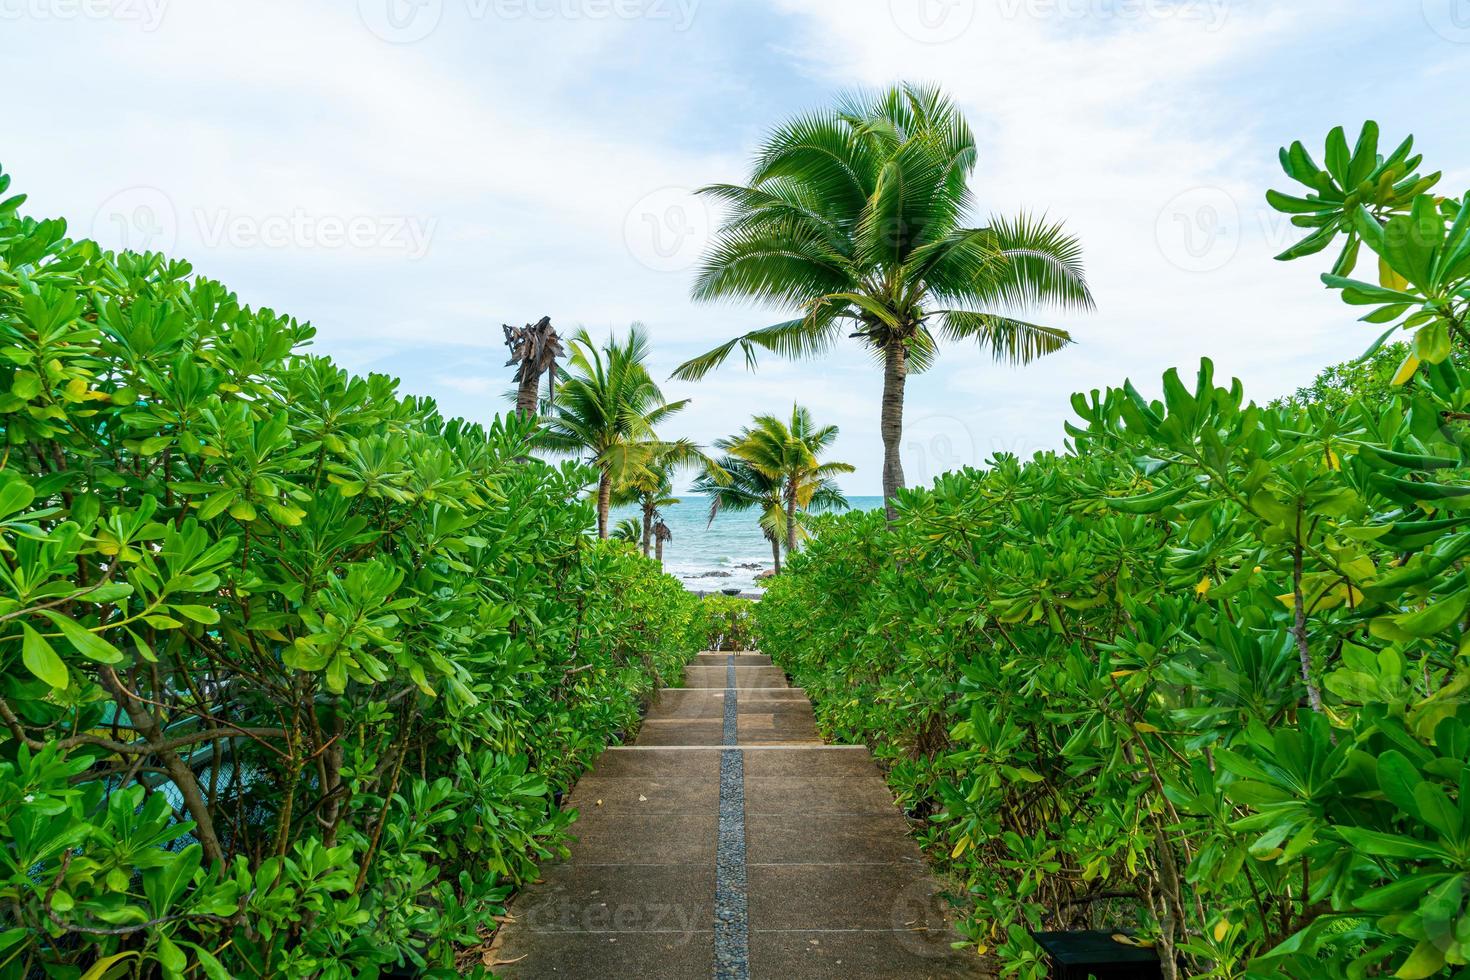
[[539, 323, 689, 538]]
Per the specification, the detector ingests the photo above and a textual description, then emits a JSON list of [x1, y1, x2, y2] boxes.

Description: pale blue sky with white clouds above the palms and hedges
[[0, 0, 1470, 494]]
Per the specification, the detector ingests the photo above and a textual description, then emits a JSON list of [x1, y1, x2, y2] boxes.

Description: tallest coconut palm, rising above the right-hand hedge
[[675, 85, 1092, 519]]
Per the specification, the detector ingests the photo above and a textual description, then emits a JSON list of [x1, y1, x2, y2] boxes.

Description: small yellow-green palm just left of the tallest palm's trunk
[[716, 404, 856, 557]]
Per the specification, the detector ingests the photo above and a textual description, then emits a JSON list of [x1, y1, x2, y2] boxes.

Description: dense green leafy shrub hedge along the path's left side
[[0, 176, 704, 980]]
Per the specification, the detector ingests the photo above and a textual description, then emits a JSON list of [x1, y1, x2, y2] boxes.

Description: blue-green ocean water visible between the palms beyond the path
[[612, 494, 883, 592]]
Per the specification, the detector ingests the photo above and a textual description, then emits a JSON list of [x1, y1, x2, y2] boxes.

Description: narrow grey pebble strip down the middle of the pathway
[[714, 654, 750, 980]]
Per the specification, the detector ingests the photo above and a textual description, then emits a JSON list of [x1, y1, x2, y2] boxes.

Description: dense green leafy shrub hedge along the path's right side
[[754, 128, 1470, 979]]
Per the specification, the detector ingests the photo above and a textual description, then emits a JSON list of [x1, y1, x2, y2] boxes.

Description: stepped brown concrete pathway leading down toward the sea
[[494, 654, 985, 980]]
